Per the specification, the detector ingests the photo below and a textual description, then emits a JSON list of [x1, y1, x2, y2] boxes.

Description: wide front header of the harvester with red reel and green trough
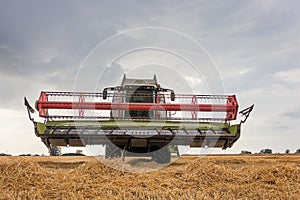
[[24, 92, 254, 149]]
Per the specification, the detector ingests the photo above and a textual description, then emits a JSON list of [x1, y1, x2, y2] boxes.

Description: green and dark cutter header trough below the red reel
[[35, 120, 240, 149]]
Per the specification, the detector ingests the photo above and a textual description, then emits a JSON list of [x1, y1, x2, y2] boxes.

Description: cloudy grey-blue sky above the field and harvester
[[0, 0, 300, 155]]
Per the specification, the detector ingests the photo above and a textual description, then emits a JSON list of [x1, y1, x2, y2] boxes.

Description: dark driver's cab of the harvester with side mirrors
[[103, 74, 175, 120]]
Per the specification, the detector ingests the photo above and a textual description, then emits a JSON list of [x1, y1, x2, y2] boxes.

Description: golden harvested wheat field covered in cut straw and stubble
[[0, 154, 300, 200]]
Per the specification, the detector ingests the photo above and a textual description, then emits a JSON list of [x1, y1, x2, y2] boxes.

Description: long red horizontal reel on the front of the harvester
[[37, 92, 238, 121]]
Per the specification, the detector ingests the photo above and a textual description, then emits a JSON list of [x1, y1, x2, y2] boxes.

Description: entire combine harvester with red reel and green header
[[25, 75, 254, 163]]
